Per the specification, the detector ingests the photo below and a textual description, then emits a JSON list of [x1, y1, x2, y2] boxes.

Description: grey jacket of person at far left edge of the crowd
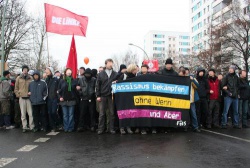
[[0, 77, 11, 100]]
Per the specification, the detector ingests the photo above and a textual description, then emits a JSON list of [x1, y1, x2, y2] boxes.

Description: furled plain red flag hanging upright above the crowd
[[66, 35, 77, 78]]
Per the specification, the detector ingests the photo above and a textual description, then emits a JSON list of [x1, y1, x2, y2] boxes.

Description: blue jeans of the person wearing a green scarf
[[62, 106, 75, 131]]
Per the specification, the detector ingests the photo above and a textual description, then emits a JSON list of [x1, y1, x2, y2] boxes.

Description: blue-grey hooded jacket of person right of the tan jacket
[[29, 71, 48, 105]]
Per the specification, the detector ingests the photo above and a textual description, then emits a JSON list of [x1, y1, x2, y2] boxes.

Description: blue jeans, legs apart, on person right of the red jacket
[[221, 96, 239, 126]]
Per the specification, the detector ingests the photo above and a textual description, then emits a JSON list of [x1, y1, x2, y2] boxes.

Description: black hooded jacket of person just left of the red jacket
[[196, 68, 210, 98]]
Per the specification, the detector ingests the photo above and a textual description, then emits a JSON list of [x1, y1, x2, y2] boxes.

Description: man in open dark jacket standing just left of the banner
[[96, 59, 118, 135]]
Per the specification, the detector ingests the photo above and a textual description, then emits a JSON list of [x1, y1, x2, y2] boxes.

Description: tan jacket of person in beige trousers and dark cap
[[14, 73, 32, 98]]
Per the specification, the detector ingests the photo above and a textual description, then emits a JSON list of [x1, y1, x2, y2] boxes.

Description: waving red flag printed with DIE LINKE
[[44, 3, 88, 36]]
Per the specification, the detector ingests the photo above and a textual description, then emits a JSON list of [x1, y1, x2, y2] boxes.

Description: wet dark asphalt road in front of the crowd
[[0, 128, 250, 168]]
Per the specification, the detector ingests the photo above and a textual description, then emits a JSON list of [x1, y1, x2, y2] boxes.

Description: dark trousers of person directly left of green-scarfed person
[[47, 99, 59, 129]]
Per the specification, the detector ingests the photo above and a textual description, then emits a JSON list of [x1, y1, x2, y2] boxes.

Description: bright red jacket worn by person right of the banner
[[208, 77, 220, 100]]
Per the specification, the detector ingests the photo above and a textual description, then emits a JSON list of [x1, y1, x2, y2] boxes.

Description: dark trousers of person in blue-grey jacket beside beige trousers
[[32, 104, 48, 130]]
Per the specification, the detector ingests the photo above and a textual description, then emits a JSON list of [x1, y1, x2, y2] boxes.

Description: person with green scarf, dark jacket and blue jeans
[[57, 68, 77, 132]]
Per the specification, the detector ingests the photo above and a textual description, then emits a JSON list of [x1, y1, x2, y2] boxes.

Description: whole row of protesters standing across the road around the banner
[[0, 58, 250, 135]]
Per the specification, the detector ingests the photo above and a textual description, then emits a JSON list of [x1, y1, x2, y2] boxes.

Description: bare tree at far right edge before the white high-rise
[[220, 0, 250, 77]]
